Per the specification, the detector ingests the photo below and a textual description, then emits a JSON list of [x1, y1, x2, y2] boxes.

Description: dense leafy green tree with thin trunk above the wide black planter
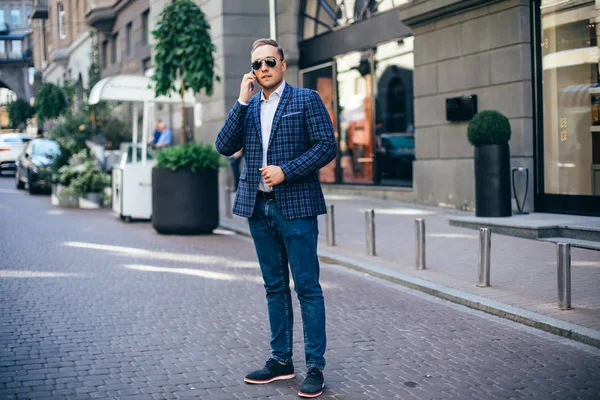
[[152, 0, 220, 144]]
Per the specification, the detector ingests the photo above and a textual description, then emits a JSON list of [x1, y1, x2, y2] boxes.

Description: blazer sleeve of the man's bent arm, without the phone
[[280, 90, 337, 182]]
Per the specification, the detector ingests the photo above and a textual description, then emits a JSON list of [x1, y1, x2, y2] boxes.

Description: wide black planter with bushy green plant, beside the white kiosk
[[152, 143, 221, 234]]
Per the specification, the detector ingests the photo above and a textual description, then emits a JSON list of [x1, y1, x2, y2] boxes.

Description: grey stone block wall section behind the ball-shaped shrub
[[400, 0, 534, 210]]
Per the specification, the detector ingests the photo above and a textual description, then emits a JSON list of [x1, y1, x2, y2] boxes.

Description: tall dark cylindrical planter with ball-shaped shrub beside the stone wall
[[467, 110, 512, 217]]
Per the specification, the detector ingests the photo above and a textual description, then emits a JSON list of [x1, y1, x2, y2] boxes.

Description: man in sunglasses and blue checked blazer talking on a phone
[[216, 39, 337, 397]]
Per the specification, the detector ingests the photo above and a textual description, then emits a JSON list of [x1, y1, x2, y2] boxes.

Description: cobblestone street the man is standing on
[[0, 178, 600, 400]]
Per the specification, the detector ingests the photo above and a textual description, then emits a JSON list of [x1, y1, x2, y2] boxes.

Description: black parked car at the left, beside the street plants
[[15, 139, 60, 194]]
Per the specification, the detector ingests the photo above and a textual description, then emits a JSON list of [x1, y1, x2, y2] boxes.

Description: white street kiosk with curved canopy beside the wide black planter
[[88, 75, 196, 221]]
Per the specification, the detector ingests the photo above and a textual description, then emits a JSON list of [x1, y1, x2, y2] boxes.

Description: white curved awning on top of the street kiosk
[[88, 75, 196, 106]]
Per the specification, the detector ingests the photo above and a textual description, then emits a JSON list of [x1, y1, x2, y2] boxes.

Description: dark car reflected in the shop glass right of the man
[[377, 133, 415, 179]]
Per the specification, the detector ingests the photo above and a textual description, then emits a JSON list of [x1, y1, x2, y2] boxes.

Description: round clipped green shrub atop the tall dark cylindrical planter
[[467, 110, 511, 146]]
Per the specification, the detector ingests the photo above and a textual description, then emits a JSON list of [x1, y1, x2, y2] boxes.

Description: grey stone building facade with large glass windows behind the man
[[189, 0, 600, 215]]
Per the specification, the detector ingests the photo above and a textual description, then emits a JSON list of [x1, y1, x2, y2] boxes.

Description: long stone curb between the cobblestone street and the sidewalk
[[219, 221, 600, 348]]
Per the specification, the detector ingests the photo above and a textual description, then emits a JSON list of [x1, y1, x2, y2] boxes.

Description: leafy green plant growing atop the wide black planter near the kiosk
[[156, 143, 224, 172]]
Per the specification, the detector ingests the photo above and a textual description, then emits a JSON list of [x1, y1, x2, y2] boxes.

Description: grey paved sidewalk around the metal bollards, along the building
[[222, 188, 600, 331]]
